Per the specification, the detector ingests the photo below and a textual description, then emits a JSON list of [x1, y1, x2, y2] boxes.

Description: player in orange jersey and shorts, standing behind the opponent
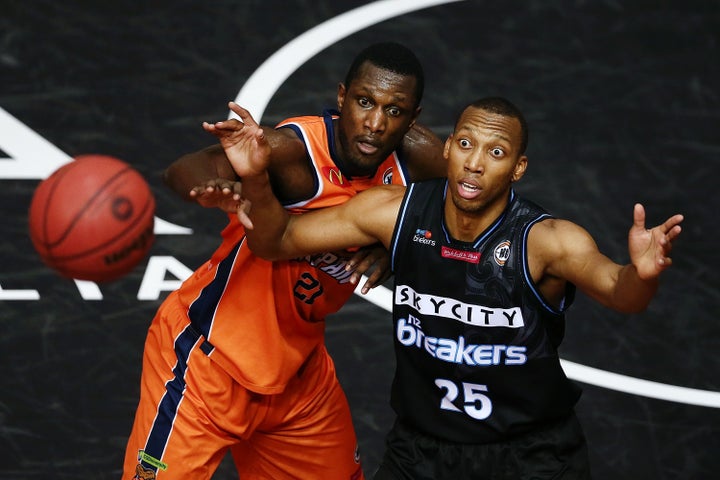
[[123, 43, 446, 480]]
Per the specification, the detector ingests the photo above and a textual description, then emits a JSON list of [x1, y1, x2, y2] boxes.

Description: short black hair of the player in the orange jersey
[[345, 42, 425, 105]]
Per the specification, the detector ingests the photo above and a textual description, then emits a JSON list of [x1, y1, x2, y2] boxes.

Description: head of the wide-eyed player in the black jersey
[[444, 97, 528, 215]]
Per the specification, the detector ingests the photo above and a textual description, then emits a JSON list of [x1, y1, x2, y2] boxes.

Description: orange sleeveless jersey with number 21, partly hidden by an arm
[[177, 114, 407, 394]]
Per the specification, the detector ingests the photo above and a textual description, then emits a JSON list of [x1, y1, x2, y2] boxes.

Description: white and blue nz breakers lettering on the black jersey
[[395, 315, 527, 367]]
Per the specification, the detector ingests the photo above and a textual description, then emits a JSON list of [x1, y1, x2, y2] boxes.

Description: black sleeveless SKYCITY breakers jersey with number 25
[[391, 179, 580, 443]]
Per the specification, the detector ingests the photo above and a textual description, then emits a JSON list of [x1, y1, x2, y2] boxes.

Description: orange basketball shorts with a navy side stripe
[[122, 295, 364, 480]]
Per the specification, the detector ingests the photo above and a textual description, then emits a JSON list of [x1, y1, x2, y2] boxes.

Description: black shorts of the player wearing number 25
[[373, 415, 591, 480]]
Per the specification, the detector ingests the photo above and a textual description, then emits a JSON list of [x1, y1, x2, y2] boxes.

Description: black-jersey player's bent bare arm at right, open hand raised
[[528, 204, 683, 313]]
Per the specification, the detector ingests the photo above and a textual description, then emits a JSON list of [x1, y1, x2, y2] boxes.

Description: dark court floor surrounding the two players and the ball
[[0, 0, 720, 480]]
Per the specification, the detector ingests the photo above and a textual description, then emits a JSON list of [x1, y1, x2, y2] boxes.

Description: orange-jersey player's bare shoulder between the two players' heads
[[402, 124, 447, 182]]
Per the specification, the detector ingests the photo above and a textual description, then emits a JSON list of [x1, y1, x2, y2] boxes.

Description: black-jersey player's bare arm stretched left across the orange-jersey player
[[203, 104, 404, 260]]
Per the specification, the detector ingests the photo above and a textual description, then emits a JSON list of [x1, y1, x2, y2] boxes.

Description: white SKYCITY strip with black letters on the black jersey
[[395, 285, 525, 328]]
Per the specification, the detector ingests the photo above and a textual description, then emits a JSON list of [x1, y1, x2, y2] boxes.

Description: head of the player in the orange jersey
[[335, 42, 425, 175]]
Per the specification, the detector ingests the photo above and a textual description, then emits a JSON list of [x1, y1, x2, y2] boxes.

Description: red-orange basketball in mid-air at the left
[[29, 155, 155, 282]]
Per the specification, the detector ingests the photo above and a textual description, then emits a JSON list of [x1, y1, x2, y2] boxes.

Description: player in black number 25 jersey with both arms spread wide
[[207, 98, 683, 480]]
